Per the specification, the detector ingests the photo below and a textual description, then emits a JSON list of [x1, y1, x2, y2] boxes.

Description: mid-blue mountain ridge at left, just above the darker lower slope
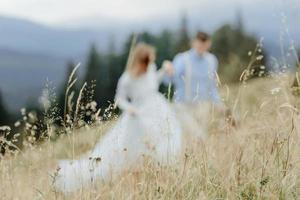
[[0, 17, 110, 57]]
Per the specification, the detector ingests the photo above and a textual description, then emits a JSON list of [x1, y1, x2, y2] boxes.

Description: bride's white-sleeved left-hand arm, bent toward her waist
[[115, 73, 134, 112]]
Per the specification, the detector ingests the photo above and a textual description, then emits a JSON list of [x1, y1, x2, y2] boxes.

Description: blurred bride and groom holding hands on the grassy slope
[[55, 32, 232, 193]]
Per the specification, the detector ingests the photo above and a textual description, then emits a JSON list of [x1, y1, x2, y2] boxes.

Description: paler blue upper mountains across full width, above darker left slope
[[0, 3, 300, 58]]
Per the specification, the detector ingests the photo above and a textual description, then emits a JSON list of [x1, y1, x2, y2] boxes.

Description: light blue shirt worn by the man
[[166, 49, 222, 104]]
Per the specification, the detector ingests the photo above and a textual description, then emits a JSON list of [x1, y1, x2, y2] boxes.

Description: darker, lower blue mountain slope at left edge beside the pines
[[0, 49, 72, 111]]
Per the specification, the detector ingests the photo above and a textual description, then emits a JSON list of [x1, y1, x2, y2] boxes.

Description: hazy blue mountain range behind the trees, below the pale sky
[[0, 0, 300, 110]]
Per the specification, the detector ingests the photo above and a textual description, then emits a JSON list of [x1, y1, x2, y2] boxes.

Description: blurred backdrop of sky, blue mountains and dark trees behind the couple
[[0, 0, 300, 125]]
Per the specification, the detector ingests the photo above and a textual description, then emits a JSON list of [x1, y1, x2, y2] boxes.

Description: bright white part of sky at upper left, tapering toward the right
[[0, 0, 257, 26]]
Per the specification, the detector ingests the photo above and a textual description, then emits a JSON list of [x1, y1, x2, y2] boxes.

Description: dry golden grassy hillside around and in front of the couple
[[0, 77, 300, 200]]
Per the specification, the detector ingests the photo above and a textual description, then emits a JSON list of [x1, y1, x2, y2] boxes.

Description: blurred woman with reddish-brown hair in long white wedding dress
[[55, 43, 181, 193]]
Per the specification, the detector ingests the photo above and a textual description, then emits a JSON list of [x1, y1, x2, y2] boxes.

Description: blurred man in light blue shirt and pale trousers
[[164, 32, 226, 139]]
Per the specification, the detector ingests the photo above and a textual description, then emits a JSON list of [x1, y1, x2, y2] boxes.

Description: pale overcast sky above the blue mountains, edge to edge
[[0, 0, 299, 29]]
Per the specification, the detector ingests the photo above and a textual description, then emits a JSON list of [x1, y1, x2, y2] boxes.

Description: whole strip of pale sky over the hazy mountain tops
[[0, 0, 300, 32]]
